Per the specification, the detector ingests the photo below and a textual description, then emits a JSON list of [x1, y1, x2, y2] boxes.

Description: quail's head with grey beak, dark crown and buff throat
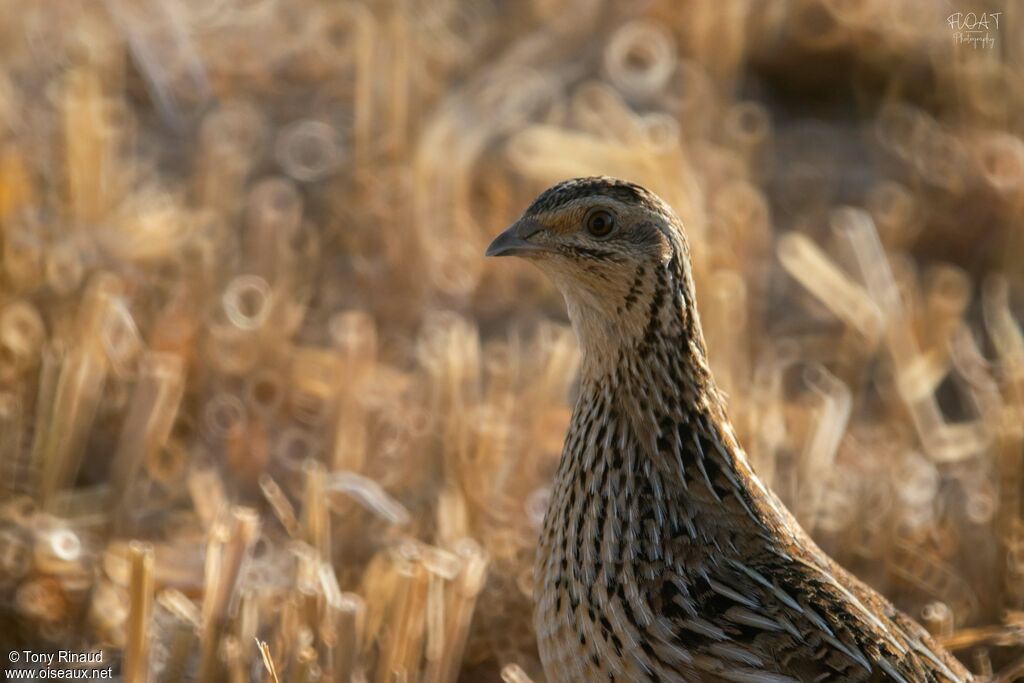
[[486, 177, 692, 362]]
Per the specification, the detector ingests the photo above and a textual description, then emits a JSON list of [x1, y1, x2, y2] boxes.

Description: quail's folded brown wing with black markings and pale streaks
[[652, 557, 972, 683]]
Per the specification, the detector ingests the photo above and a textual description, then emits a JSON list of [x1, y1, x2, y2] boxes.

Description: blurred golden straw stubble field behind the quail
[[0, 0, 1024, 683]]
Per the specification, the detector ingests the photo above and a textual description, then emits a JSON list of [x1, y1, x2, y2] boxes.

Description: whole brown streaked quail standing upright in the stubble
[[486, 177, 972, 683]]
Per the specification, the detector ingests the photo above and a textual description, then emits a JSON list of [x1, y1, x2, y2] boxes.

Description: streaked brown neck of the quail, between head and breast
[[563, 268, 777, 526]]
